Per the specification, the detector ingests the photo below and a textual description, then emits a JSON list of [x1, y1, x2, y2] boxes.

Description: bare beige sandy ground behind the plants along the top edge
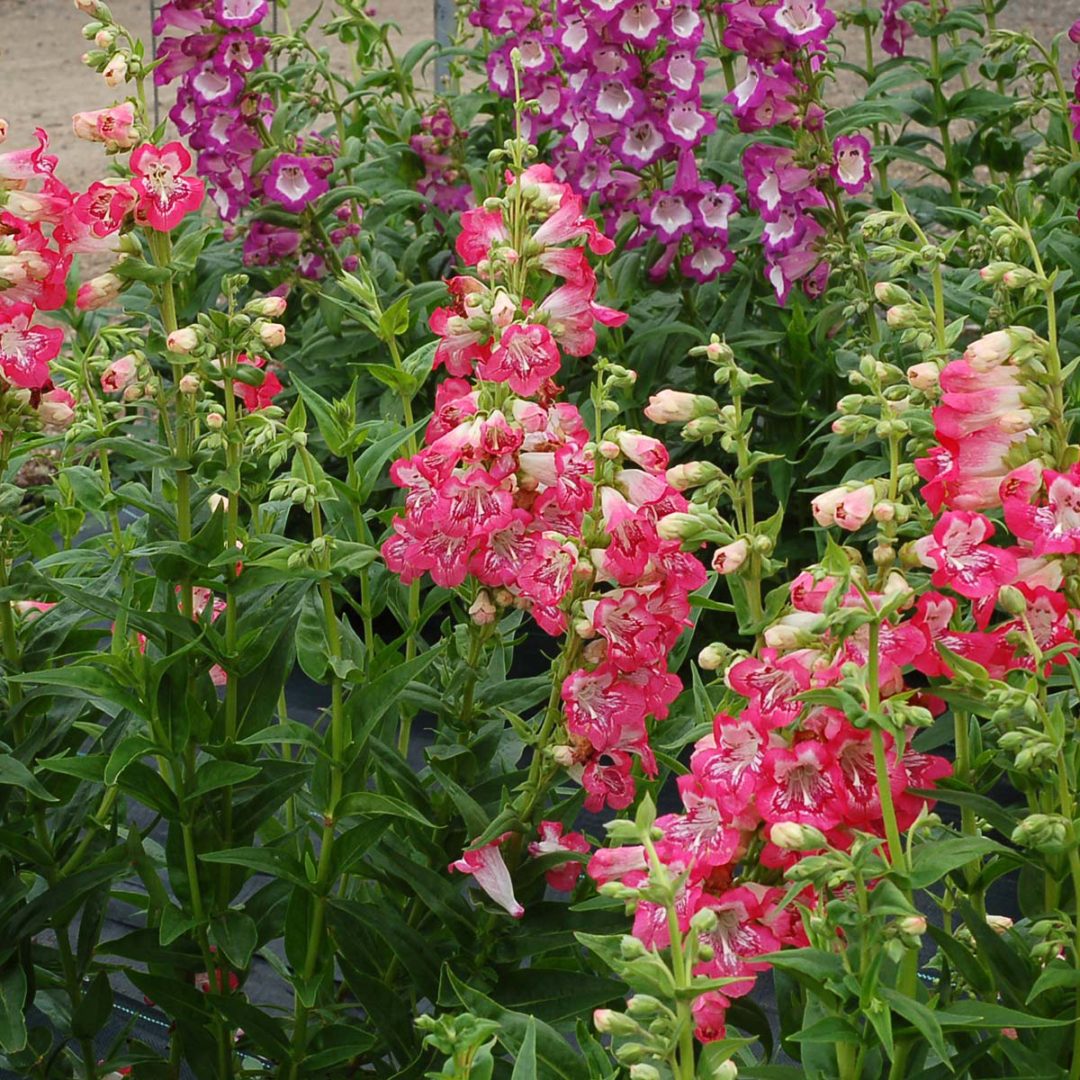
[[0, 0, 1078, 186]]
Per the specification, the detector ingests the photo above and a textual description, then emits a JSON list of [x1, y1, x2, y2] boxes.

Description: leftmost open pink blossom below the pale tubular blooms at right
[[916, 510, 1016, 599]]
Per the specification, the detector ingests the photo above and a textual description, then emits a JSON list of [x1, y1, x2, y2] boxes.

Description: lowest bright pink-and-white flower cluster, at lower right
[[589, 572, 950, 1042]]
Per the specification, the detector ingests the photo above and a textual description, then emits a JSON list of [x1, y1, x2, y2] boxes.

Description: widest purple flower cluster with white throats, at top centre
[[470, 0, 739, 281]]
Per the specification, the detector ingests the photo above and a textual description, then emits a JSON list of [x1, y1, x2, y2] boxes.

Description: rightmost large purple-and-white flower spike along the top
[[720, 0, 870, 303]]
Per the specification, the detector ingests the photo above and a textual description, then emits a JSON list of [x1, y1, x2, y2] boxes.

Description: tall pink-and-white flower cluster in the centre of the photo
[[382, 165, 705, 909]]
